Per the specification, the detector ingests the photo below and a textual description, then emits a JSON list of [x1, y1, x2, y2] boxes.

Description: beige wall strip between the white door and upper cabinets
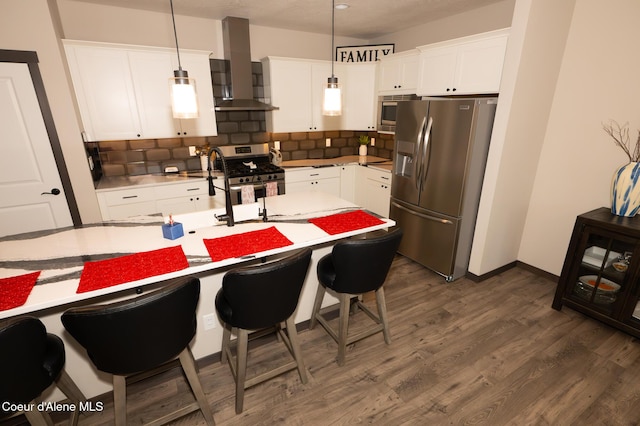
[[0, 0, 102, 223]]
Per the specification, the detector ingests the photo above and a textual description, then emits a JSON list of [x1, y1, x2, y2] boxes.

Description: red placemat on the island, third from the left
[[202, 226, 293, 262]]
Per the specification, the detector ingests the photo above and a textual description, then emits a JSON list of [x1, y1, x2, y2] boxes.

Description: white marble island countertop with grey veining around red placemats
[[0, 193, 395, 318]]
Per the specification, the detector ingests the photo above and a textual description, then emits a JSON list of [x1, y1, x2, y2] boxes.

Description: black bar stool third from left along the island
[[215, 249, 311, 414]]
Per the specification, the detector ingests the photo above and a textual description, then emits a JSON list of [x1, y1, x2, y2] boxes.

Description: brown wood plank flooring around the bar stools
[[27, 256, 640, 426]]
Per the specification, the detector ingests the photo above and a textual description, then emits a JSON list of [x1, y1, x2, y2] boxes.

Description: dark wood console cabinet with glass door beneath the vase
[[552, 207, 640, 337]]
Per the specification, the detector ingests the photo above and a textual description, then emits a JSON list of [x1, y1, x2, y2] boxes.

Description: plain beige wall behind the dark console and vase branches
[[518, 0, 640, 275]]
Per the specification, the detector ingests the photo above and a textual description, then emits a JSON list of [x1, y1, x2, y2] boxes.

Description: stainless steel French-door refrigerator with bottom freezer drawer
[[389, 98, 497, 281]]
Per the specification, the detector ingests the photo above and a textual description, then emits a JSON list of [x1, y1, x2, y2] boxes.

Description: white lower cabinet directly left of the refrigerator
[[356, 167, 391, 217]]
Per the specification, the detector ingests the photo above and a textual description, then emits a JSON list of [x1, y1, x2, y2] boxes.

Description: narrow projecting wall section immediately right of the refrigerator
[[469, 0, 575, 275]]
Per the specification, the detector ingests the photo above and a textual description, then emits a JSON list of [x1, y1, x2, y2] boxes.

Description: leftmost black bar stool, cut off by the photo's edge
[[0, 317, 86, 425]]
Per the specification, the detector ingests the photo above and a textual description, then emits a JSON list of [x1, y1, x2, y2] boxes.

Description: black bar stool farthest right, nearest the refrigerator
[[309, 228, 402, 365]]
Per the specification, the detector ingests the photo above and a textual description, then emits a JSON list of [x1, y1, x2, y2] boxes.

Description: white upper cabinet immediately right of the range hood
[[262, 57, 341, 133]]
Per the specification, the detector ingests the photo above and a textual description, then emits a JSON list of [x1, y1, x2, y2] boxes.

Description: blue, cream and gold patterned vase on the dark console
[[611, 162, 640, 217]]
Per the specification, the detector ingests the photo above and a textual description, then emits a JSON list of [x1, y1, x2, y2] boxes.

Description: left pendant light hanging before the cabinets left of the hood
[[169, 0, 199, 118]]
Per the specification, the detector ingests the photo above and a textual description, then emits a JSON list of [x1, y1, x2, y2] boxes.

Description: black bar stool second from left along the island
[[62, 278, 215, 426]]
